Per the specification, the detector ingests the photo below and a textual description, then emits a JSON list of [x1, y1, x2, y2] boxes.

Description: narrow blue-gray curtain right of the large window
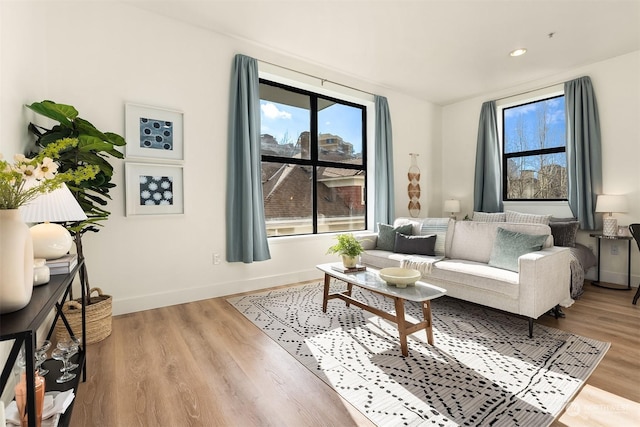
[[373, 95, 395, 227]]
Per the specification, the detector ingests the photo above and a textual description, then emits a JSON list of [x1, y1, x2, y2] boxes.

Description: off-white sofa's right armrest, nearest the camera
[[518, 246, 573, 318]]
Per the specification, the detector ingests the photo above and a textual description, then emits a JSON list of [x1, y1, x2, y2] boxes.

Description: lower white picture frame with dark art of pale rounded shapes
[[125, 162, 184, 216]]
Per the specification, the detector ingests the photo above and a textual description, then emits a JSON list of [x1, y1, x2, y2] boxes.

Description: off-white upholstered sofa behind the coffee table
[[360, 218, 573, 336]]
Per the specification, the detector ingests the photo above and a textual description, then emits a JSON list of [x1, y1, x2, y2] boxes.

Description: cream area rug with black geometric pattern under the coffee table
[[228, 282, 609, 427]]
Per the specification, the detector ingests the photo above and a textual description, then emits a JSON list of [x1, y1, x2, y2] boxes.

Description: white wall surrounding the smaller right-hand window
[[442, 52, 640, 286]]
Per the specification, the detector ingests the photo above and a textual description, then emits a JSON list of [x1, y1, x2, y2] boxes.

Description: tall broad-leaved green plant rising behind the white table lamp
[[27, 100, 126, 342]]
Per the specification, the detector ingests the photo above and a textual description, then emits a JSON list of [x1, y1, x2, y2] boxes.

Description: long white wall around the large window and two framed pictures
[[0, 2, 440, 314]]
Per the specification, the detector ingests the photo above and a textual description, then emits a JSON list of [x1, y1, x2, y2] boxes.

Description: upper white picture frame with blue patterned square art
[[125, 103, 184, 161]]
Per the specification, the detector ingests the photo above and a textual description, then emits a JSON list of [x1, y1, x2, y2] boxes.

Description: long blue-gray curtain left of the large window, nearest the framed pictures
[[226, 55, 271, 263]]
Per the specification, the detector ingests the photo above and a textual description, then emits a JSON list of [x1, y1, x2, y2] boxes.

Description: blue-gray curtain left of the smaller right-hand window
[[473, 101, 503, 212]]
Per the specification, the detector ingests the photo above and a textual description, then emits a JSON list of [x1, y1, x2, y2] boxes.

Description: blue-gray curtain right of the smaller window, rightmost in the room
[[564, 77, 602, 230]]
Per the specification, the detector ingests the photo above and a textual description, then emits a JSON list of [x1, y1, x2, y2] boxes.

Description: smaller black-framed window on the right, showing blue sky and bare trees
[[502, 95, 568, 201]]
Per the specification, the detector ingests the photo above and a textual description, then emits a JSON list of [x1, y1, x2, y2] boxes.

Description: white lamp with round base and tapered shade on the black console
[[20, 184, 87, 259]]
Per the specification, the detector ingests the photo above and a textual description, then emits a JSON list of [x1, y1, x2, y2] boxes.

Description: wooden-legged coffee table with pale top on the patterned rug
[[316, 263, 447, 356]]
